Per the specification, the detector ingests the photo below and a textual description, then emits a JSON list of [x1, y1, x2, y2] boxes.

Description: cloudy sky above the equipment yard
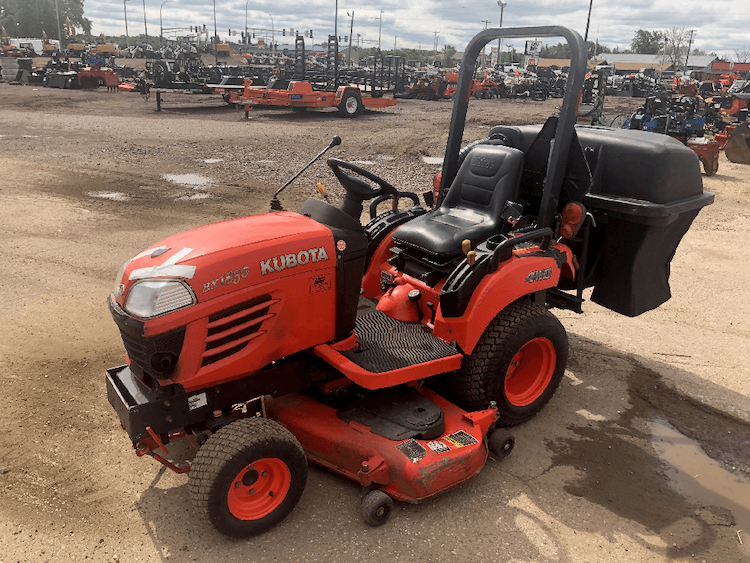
[[84, 0, 750, 60]]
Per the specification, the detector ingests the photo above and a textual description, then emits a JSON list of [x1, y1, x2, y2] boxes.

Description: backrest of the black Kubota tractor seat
[[441, 145, 524, 218]]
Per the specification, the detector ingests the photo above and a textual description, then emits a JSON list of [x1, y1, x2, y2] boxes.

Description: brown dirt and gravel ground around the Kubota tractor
[[0, 84, 750, 563]]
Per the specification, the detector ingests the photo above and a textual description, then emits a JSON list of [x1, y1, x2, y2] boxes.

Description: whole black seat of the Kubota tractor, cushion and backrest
[[393, 145, 524, 262]]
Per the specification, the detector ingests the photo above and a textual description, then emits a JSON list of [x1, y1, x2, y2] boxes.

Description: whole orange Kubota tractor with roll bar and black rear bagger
[[106, 27, 713, 537]]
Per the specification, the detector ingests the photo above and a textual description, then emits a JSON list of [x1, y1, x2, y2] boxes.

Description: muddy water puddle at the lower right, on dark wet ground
[[649, 420, 750, 555]]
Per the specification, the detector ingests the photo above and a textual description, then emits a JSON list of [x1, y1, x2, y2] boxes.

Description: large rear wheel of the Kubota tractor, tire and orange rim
[[451, 300, 568, 426]]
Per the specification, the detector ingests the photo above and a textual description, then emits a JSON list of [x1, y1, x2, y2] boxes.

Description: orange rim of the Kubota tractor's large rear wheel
[[505, 337, 557, 407]]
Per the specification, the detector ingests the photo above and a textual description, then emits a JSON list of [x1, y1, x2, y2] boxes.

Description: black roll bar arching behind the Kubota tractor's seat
[[444, 26, 588, 228]]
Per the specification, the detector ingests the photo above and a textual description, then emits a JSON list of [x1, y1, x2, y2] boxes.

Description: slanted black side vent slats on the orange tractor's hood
[[201, 295, 279, 367]]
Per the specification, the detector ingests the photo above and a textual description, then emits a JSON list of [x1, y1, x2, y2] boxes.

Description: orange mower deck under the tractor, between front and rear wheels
[[265, 388, 497, 502]]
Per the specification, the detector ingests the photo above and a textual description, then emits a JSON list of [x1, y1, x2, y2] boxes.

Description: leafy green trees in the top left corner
[[0, 0, 91, 39]]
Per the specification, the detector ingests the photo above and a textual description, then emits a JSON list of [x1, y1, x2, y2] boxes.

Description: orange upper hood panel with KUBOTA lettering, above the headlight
[[115, 211, 336, 311]]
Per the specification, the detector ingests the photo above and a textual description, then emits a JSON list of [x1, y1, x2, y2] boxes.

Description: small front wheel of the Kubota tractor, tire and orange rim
[[188, 418, 307, 538]]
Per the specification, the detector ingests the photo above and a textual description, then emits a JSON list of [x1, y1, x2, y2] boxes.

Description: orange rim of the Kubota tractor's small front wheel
[[227, 457, 292, 520]]
